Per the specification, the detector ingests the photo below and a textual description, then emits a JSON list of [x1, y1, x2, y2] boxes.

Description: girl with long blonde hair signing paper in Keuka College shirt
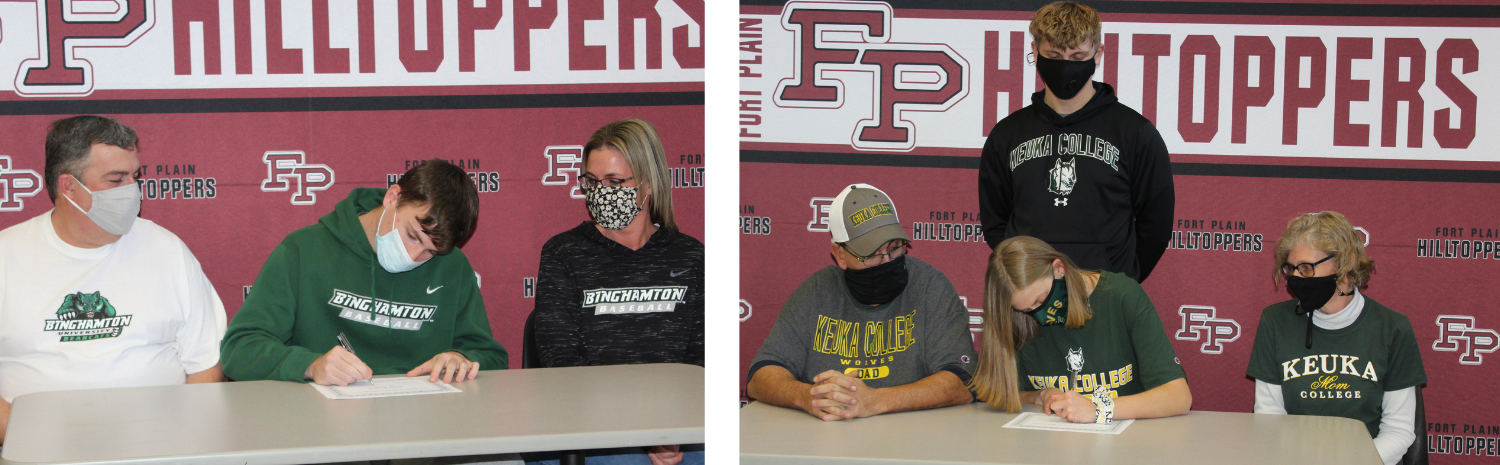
[[969, 236, 1193, 423]]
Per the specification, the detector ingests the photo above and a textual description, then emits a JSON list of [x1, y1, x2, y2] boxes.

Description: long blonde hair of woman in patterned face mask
[[584, 119, 677, 231]]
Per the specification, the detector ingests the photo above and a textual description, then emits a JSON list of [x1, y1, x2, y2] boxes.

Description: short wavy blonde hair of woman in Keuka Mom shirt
[[1271, 212, 1376, 290]]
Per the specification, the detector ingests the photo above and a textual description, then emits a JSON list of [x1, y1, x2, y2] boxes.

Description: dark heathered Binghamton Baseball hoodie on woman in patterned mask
[[533, 221, 704, 368]]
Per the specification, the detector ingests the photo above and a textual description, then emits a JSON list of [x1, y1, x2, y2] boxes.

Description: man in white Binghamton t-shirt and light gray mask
[[0, 116, 225, 438]]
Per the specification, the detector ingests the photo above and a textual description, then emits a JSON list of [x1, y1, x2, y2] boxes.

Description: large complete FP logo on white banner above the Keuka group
[[773, 2, 969, 152]]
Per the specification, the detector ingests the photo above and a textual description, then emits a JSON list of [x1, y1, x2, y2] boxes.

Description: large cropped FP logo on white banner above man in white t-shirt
[[15, 0, 156, 98]]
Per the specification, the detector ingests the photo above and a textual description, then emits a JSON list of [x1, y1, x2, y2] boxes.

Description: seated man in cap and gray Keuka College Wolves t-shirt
[[747, 185, 975, 420]]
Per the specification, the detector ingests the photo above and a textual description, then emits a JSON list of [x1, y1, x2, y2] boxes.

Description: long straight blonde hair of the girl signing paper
[[969, 236, 1094, 413]]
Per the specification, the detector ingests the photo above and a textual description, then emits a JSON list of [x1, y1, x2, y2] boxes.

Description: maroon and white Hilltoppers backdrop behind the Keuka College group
[[738, 2, 1500, 464]]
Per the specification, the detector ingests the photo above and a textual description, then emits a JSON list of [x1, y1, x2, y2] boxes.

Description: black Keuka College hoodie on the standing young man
[[980, 83, 1176, 281]]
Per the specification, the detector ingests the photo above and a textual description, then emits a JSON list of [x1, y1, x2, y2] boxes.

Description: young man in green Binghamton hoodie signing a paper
[[221, 159, 507, 386]]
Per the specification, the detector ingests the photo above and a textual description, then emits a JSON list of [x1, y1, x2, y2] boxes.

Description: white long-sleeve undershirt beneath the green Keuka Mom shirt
[[1256, 290, 1416, 465]]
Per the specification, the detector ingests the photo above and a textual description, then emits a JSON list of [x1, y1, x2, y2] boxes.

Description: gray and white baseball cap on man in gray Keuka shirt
[[828, 185, 912, 257]]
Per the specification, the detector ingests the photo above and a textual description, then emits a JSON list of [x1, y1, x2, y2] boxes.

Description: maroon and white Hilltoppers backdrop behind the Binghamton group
[[0, 0, 704, 368]]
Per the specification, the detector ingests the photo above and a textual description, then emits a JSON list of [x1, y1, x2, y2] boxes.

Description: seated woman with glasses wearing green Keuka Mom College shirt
[[1247, 212, 1427, 465]]
